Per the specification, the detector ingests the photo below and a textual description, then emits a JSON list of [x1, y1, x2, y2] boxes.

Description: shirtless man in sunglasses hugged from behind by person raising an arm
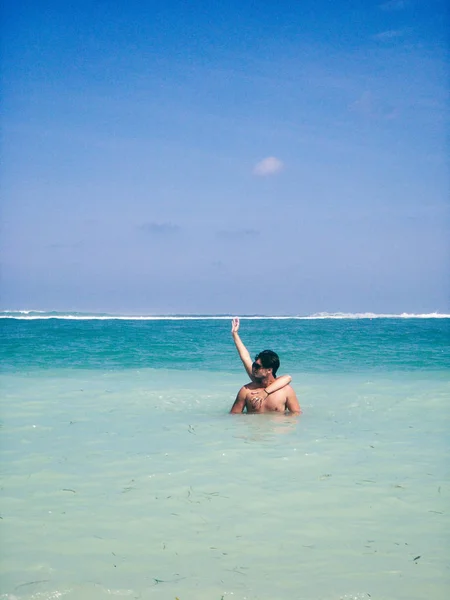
[[231, 318, 301, 415]]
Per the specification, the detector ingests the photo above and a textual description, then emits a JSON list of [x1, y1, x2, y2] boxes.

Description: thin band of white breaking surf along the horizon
[[0, 310, 450, 321]]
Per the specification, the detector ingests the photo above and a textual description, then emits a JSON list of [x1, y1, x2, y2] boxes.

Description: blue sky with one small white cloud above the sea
[[0, 0, 450, 315]]
